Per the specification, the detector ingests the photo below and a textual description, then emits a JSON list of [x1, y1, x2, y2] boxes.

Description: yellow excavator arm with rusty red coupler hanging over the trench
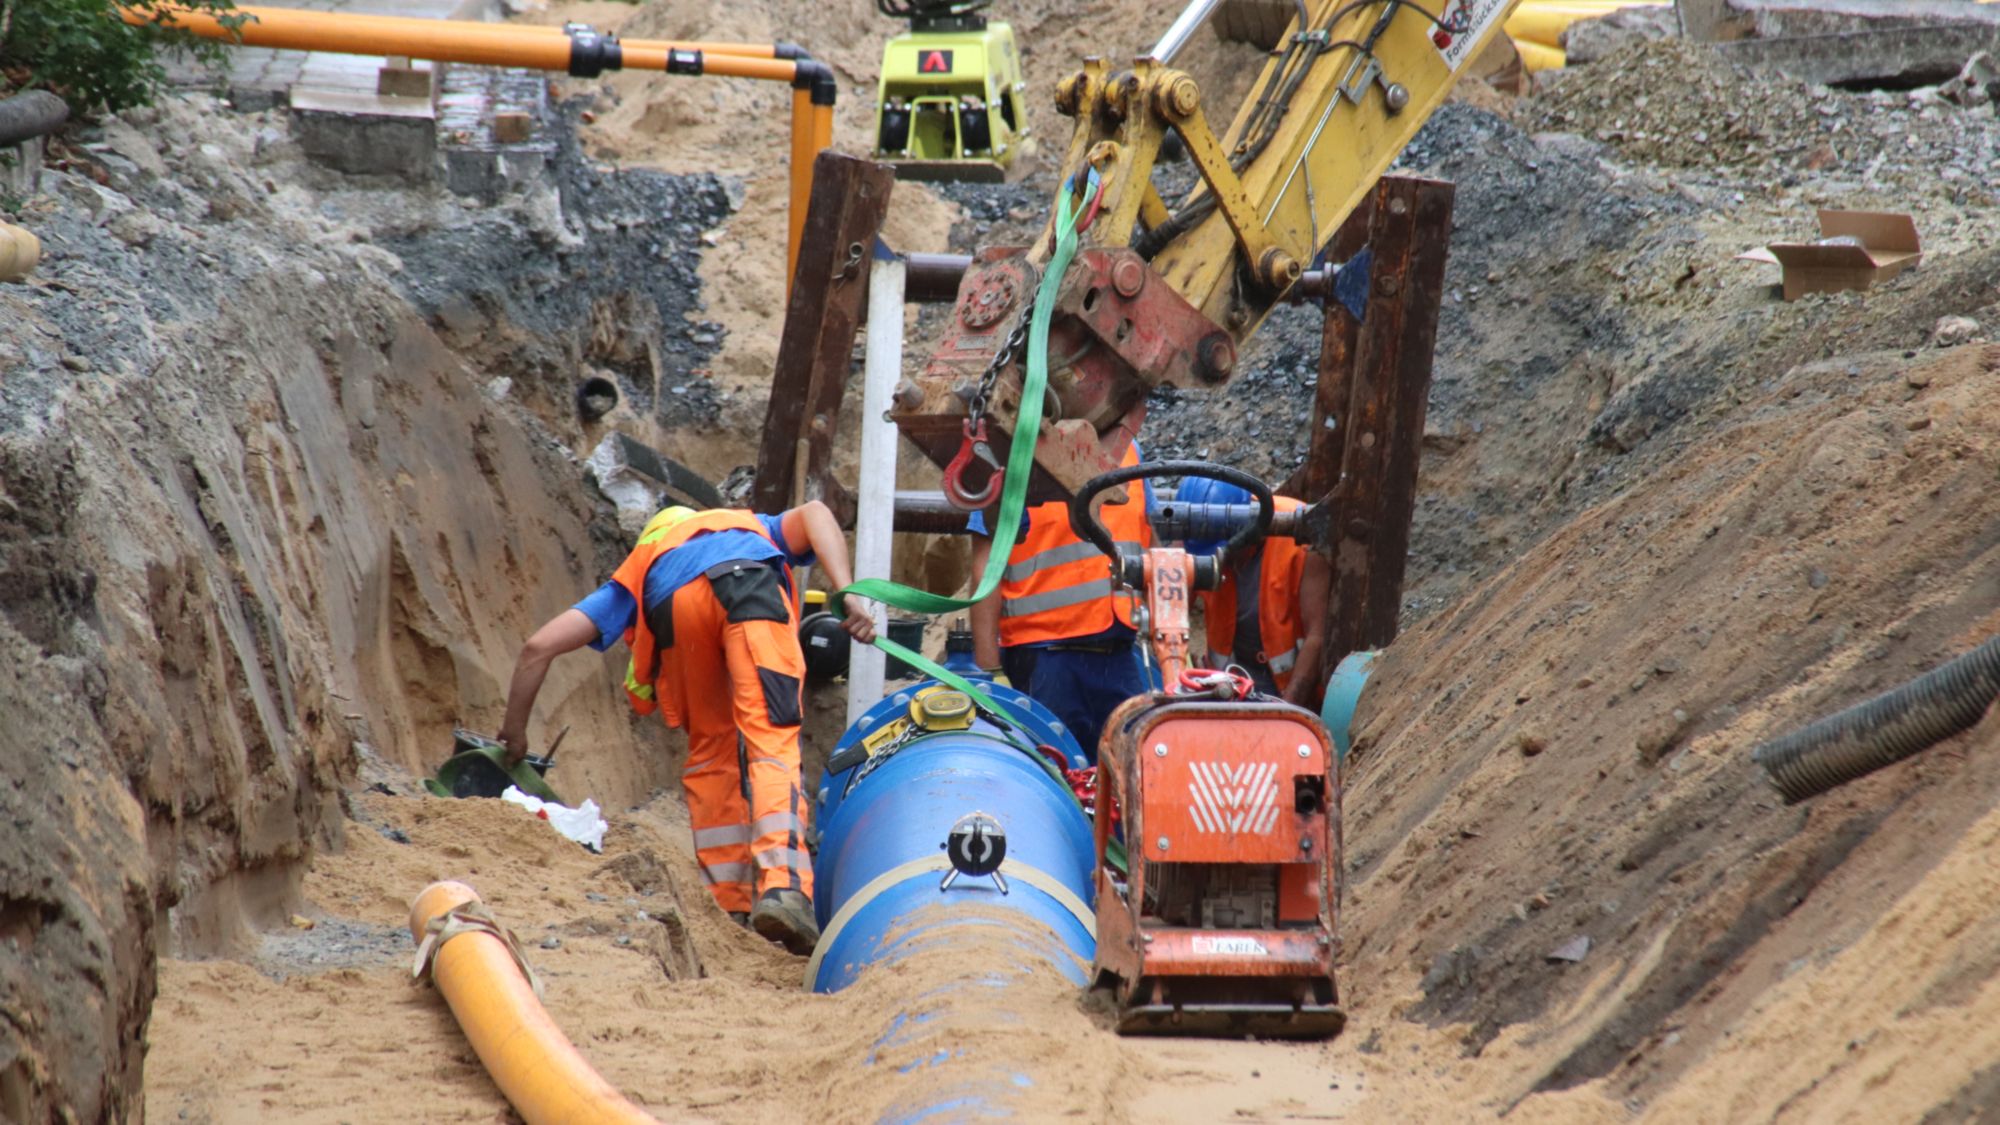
[[892, 0, 1516, 500]]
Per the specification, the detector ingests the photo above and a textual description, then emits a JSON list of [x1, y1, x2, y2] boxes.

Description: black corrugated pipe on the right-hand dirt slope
[[1750, 637, 2000, 803]]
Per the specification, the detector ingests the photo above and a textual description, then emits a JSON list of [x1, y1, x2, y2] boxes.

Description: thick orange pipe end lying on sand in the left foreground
[[410, 883, 658, 1125]]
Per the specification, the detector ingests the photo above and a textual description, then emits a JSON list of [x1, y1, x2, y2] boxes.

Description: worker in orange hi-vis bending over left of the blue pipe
[[500, 500, 874, 953]]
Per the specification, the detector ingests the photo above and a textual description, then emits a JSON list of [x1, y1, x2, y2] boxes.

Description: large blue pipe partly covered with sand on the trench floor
[[806, 681, 1096, 1125]]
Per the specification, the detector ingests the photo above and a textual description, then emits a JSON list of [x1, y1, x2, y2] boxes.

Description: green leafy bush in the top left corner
[[0, 0, 240, 112]]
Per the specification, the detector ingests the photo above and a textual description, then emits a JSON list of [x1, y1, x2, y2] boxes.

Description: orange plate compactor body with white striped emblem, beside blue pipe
[[1096, 695, 1346, 1039]]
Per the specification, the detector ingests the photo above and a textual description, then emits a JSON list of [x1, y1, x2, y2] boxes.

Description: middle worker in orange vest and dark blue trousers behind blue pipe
[[970, 422, 1152, 761]]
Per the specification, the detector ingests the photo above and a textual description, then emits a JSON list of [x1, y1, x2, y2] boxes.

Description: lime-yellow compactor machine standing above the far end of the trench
[[874, 16, 1032, 184]]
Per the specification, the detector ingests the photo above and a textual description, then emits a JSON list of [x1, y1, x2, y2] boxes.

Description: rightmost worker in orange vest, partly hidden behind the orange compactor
[[1174, 476, 1334, 709]]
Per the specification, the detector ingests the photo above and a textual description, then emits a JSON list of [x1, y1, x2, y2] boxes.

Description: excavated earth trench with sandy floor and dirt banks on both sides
[[11, 19, 2000, 1121]]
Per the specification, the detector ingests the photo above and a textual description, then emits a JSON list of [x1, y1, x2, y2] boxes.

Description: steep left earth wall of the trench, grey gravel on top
[[0, 94, 720, 1121]]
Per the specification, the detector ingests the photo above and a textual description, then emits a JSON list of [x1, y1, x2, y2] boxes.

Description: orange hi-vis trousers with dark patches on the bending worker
[[666, 565, 812, 913]]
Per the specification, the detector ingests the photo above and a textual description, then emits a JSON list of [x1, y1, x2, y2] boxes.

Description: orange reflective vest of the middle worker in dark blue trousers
[[1000, 444, 1152, 647]]
